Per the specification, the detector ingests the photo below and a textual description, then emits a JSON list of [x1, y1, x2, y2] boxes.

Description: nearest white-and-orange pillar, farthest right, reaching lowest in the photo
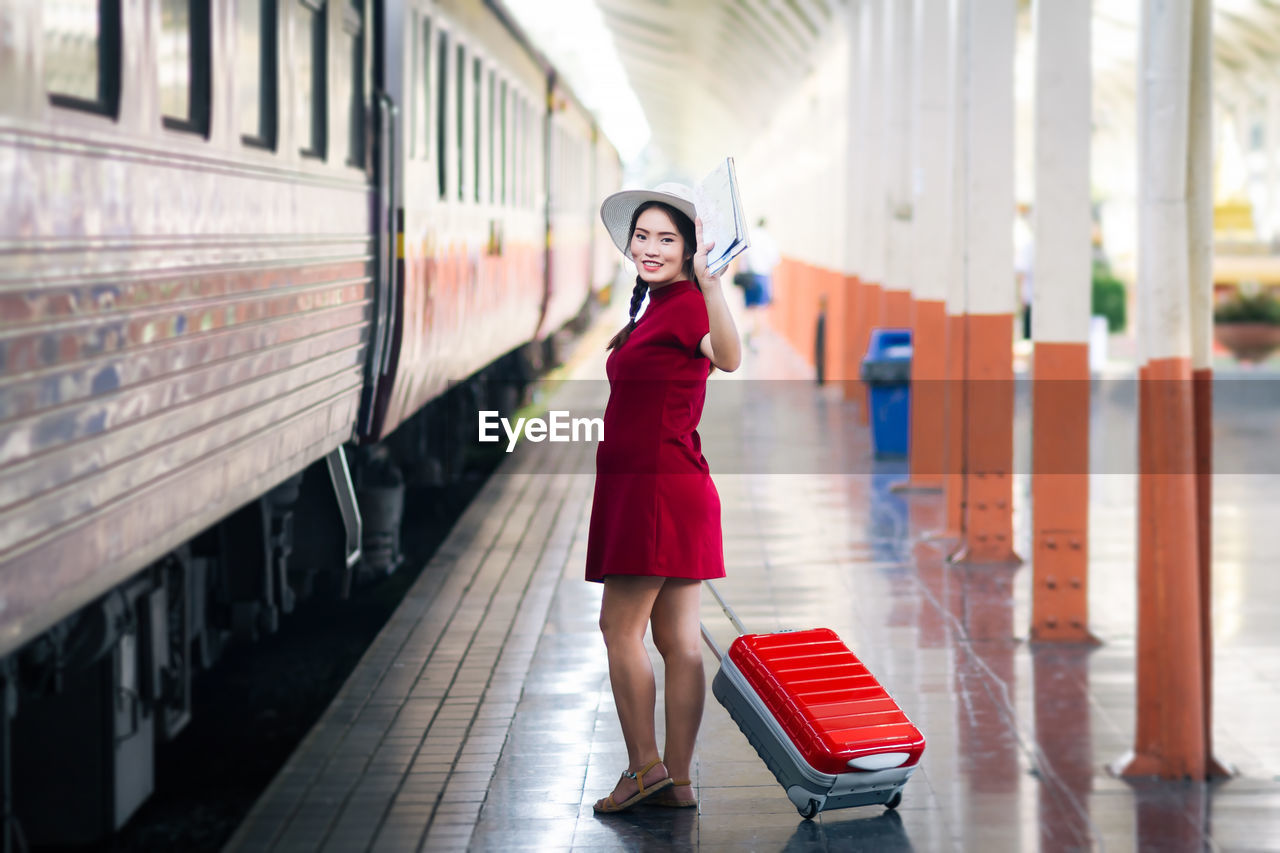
[[1123, 0, 1207, 780]]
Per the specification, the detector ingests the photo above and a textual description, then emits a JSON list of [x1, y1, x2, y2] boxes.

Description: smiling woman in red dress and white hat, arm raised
[[586, 183, 741, 813]]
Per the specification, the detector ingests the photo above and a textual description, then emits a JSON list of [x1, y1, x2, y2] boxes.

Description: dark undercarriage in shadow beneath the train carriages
[[0, 343, 554, 850]]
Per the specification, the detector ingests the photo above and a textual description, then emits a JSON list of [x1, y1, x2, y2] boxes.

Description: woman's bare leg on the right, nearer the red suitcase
[[653, 578, 707, 799]]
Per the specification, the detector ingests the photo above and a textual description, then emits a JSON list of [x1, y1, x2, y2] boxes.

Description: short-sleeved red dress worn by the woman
[[586, 282, 724, 581]]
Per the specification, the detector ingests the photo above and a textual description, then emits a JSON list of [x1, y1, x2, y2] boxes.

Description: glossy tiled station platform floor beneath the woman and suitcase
[[228, 315, 1280, 852]]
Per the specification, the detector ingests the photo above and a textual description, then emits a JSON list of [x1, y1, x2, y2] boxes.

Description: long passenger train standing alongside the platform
[[0, 0, 622, 845]]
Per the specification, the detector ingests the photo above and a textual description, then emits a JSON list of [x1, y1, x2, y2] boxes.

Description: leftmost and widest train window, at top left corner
[[42, 0, 120, 118]]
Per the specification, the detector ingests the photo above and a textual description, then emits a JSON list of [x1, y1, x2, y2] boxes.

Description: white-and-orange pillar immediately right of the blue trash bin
[[910, 0, 954, 489]]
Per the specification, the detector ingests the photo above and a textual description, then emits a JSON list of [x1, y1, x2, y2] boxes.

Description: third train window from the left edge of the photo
[[236, 0, 278, 151]]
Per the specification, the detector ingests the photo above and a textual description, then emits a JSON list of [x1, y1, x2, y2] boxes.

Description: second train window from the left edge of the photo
[[156, 0, 210, 133]]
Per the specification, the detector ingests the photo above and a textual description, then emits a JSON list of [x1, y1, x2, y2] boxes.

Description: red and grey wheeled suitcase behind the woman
[[704, 581, 924, 818]]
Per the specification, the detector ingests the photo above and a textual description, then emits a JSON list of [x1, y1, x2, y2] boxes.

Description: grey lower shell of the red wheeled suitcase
[[712, 654, 919, 818]]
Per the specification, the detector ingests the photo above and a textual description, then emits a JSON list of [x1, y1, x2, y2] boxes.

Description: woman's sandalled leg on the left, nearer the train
[[600, 575, 667, 803]]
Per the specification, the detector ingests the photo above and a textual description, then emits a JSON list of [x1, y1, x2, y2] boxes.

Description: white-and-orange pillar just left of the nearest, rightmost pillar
[[1032, 0, 1093, 643]]
